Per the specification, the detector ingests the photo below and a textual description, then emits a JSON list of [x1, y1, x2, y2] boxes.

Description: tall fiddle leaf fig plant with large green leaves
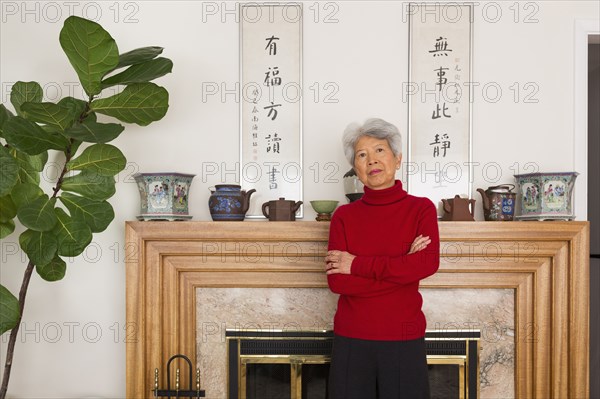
[[0, 16, 173, 399]]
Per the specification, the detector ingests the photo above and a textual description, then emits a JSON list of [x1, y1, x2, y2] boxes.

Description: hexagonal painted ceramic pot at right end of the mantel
[[515, 172, 579, 220]]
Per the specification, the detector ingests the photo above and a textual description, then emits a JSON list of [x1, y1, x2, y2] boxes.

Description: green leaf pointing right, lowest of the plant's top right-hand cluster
[[92, 82, 169, 126]]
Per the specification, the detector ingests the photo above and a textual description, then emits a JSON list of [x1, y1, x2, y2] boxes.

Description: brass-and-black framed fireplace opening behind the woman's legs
[[225, 330, 481, 399]]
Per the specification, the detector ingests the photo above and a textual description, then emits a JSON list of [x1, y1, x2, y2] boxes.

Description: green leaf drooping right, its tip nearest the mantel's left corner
[[59, 192, 115, 233]]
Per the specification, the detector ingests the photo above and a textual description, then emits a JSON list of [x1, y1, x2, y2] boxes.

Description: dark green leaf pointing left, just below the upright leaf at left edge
[[4, 116, 70, 155]]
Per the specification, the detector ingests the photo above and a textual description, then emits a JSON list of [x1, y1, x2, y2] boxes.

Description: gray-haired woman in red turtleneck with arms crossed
[[326, 119, 440, 399]]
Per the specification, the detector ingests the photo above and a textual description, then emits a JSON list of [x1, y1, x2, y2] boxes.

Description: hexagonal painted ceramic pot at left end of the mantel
[[133, 172, 195, 220]]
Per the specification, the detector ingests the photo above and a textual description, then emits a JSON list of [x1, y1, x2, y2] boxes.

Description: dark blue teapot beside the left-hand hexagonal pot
[[208, 184, 256, 221]]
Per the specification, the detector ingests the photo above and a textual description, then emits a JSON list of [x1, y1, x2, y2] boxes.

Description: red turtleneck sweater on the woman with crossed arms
[[328, 180, 440, 341]]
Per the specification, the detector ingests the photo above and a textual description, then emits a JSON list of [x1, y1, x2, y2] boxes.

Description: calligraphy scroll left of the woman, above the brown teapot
[[240, 3, 302, 217]]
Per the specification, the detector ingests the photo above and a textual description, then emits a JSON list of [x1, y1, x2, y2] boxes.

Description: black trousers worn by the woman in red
[[329, 335, 429, 399]]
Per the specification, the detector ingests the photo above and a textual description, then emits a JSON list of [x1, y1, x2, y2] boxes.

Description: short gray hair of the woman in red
[[342, 118, 402, 167]]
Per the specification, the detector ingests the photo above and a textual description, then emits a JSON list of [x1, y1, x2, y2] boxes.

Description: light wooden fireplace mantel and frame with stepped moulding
[[126, 221, 589, 398]]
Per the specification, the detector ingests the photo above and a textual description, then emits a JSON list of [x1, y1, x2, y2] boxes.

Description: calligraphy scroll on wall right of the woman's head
[[406, 3, 473, 214]]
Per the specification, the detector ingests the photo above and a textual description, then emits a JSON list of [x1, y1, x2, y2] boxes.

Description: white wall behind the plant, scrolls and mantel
[[0, 0, 599, 398]]
